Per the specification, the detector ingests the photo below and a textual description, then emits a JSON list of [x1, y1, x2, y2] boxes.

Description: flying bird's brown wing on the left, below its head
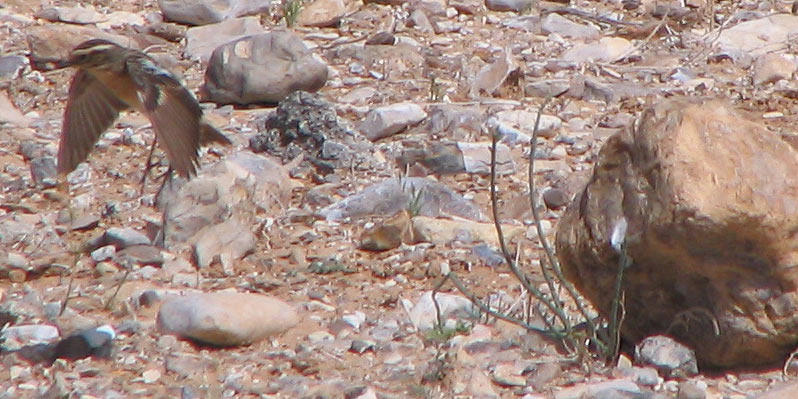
[[58, 70, 129, 174]]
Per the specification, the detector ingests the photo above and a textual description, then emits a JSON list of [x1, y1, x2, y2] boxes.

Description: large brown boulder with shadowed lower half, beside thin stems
[[556, 100, 798, 367]]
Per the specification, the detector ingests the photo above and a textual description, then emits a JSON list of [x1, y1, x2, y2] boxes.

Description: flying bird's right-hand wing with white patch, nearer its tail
[[127, 57, 202, 177]]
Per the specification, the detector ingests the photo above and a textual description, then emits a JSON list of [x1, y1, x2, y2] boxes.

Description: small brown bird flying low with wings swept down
[[58, 39, 231, 178]]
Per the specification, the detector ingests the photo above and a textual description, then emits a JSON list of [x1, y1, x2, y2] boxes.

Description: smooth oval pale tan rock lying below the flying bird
[[157, 291, 299, 346]]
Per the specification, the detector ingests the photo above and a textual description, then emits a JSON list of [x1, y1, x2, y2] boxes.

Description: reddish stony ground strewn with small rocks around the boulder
[[0, 0, 798, 399]]
